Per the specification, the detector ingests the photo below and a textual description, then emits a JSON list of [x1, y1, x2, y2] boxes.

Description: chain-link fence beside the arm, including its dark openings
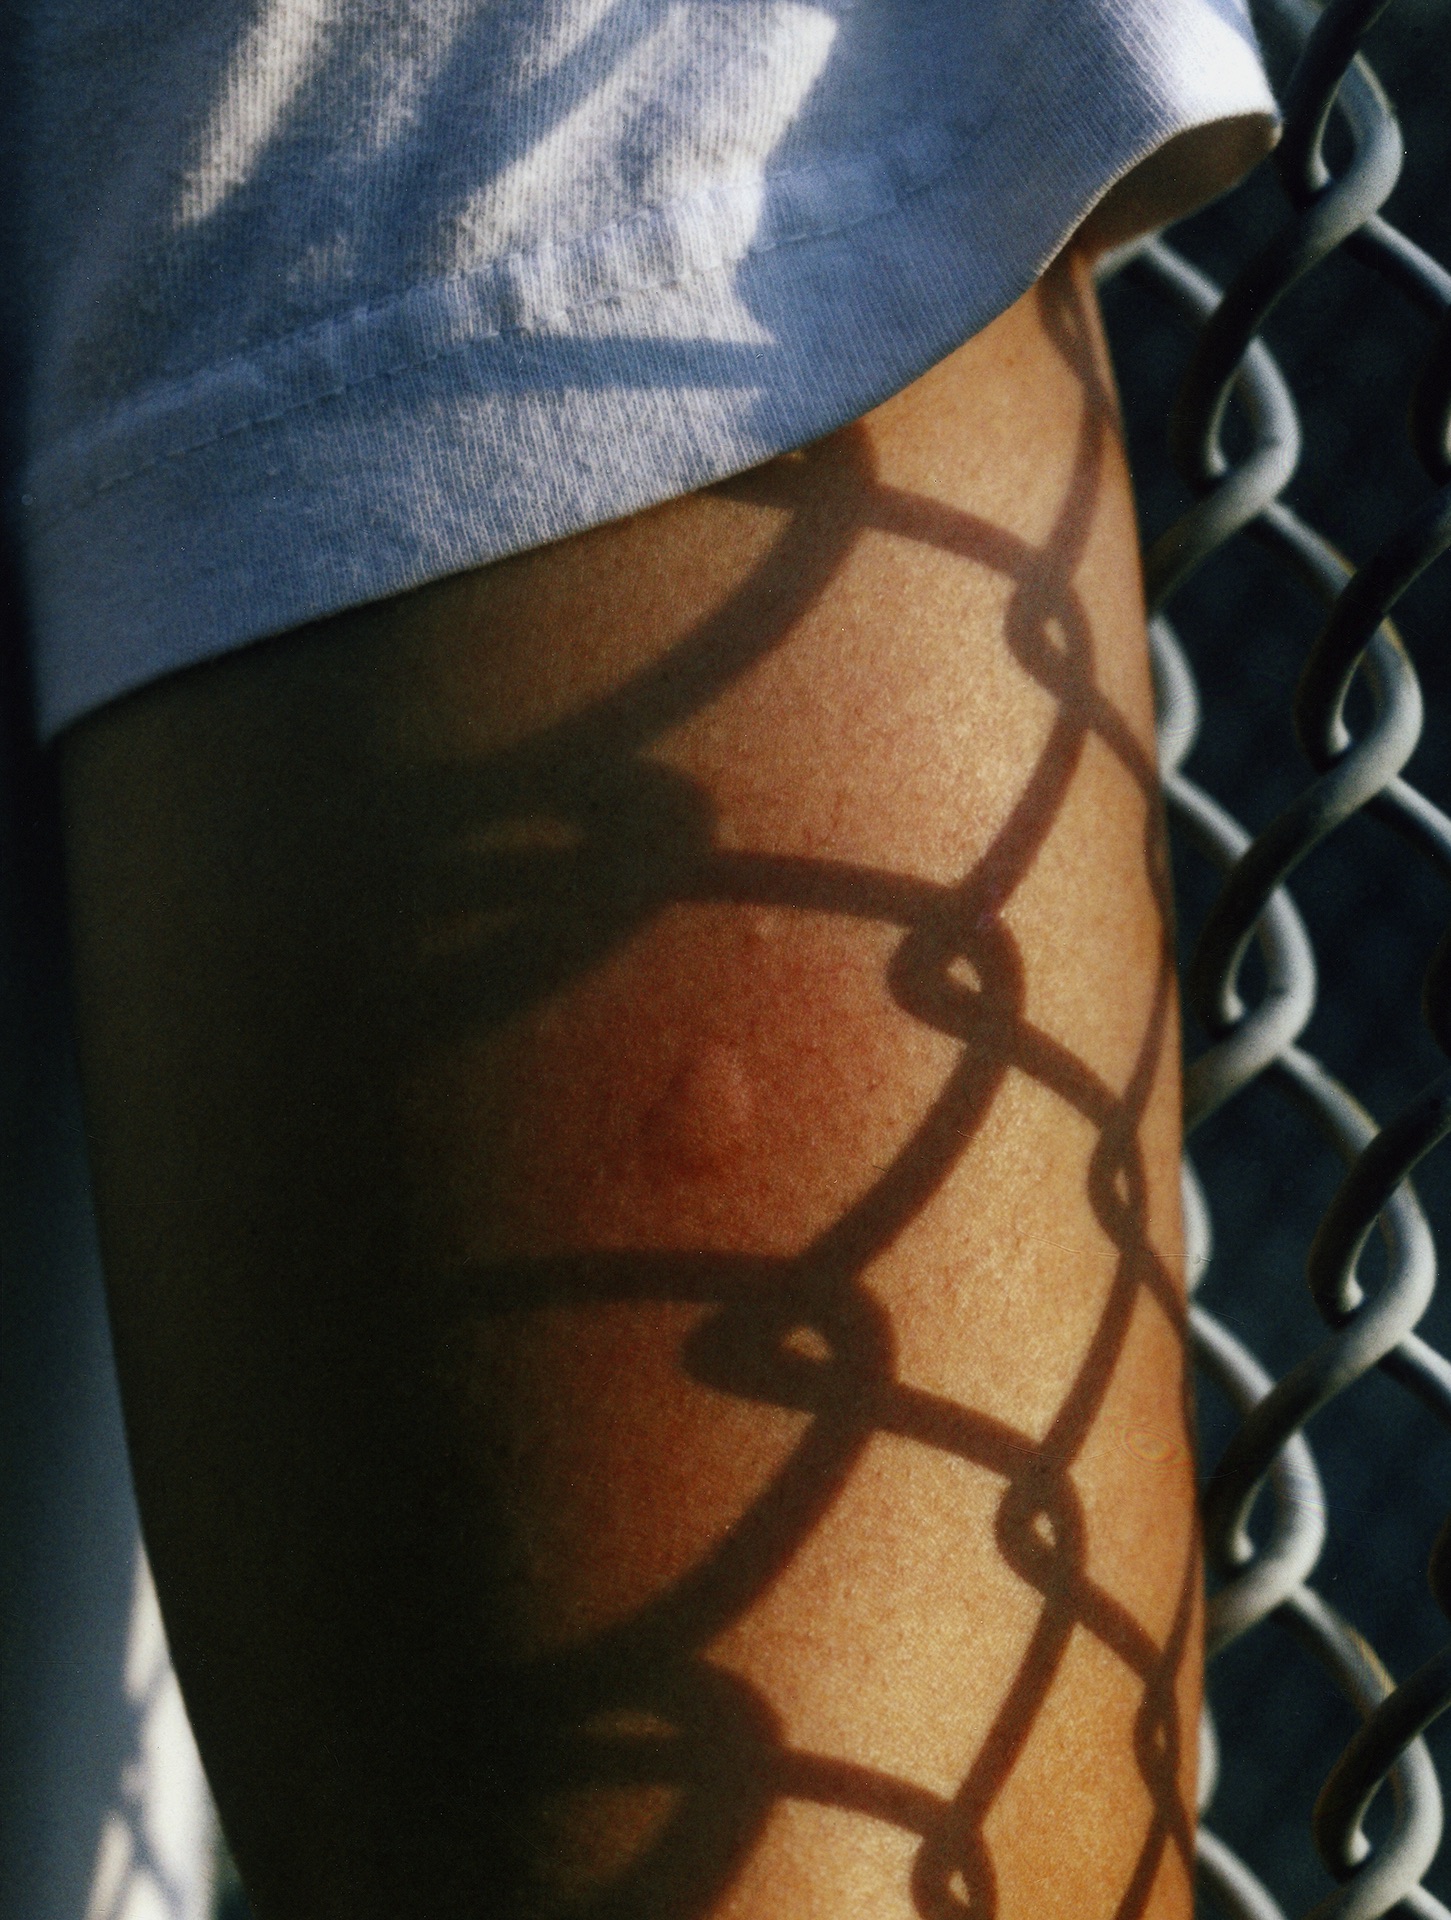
[[1106, 0, 1451, 1920]]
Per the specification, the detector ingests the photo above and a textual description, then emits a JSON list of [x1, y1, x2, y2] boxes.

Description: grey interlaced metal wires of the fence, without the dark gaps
[[1097, 0, 1451, 1920]]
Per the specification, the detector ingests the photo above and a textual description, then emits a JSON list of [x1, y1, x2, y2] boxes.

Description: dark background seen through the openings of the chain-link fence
[[1104, 0, 1451, 1914]]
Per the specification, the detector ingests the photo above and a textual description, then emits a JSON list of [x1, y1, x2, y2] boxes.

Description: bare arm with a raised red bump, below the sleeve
[[63, 251, 1198, 1920]]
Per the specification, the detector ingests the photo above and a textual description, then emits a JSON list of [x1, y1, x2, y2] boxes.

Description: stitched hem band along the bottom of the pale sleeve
[[25, 0, 1274, 737]]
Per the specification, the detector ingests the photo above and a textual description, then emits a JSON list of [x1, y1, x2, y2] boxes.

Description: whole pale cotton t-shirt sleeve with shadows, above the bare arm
[[4, 0, 1273, 733]]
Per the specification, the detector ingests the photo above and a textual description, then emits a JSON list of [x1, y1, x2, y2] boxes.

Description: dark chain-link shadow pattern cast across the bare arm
[[364, 276, 1200, 1920]]
